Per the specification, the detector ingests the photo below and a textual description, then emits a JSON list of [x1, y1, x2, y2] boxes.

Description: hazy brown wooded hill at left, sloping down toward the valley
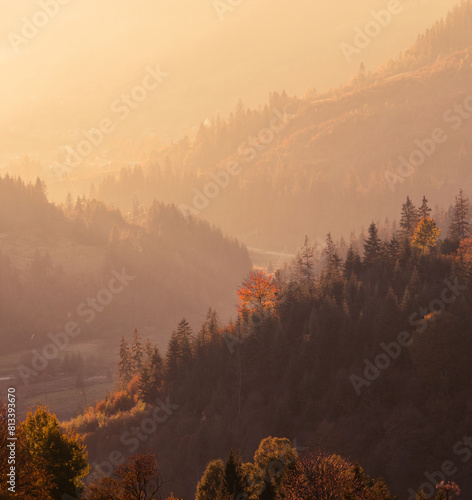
[[0, 176, 251, 360]]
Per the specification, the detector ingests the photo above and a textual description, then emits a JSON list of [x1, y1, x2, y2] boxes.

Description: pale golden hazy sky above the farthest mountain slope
[[0, 0, 456, 154]]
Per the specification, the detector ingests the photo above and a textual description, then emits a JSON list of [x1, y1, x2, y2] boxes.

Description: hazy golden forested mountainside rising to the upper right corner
[[93, 1, 472, 251]]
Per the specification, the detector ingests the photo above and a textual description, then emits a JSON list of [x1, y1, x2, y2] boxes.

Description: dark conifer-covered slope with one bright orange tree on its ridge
[[65, 193, 472, 498]]
